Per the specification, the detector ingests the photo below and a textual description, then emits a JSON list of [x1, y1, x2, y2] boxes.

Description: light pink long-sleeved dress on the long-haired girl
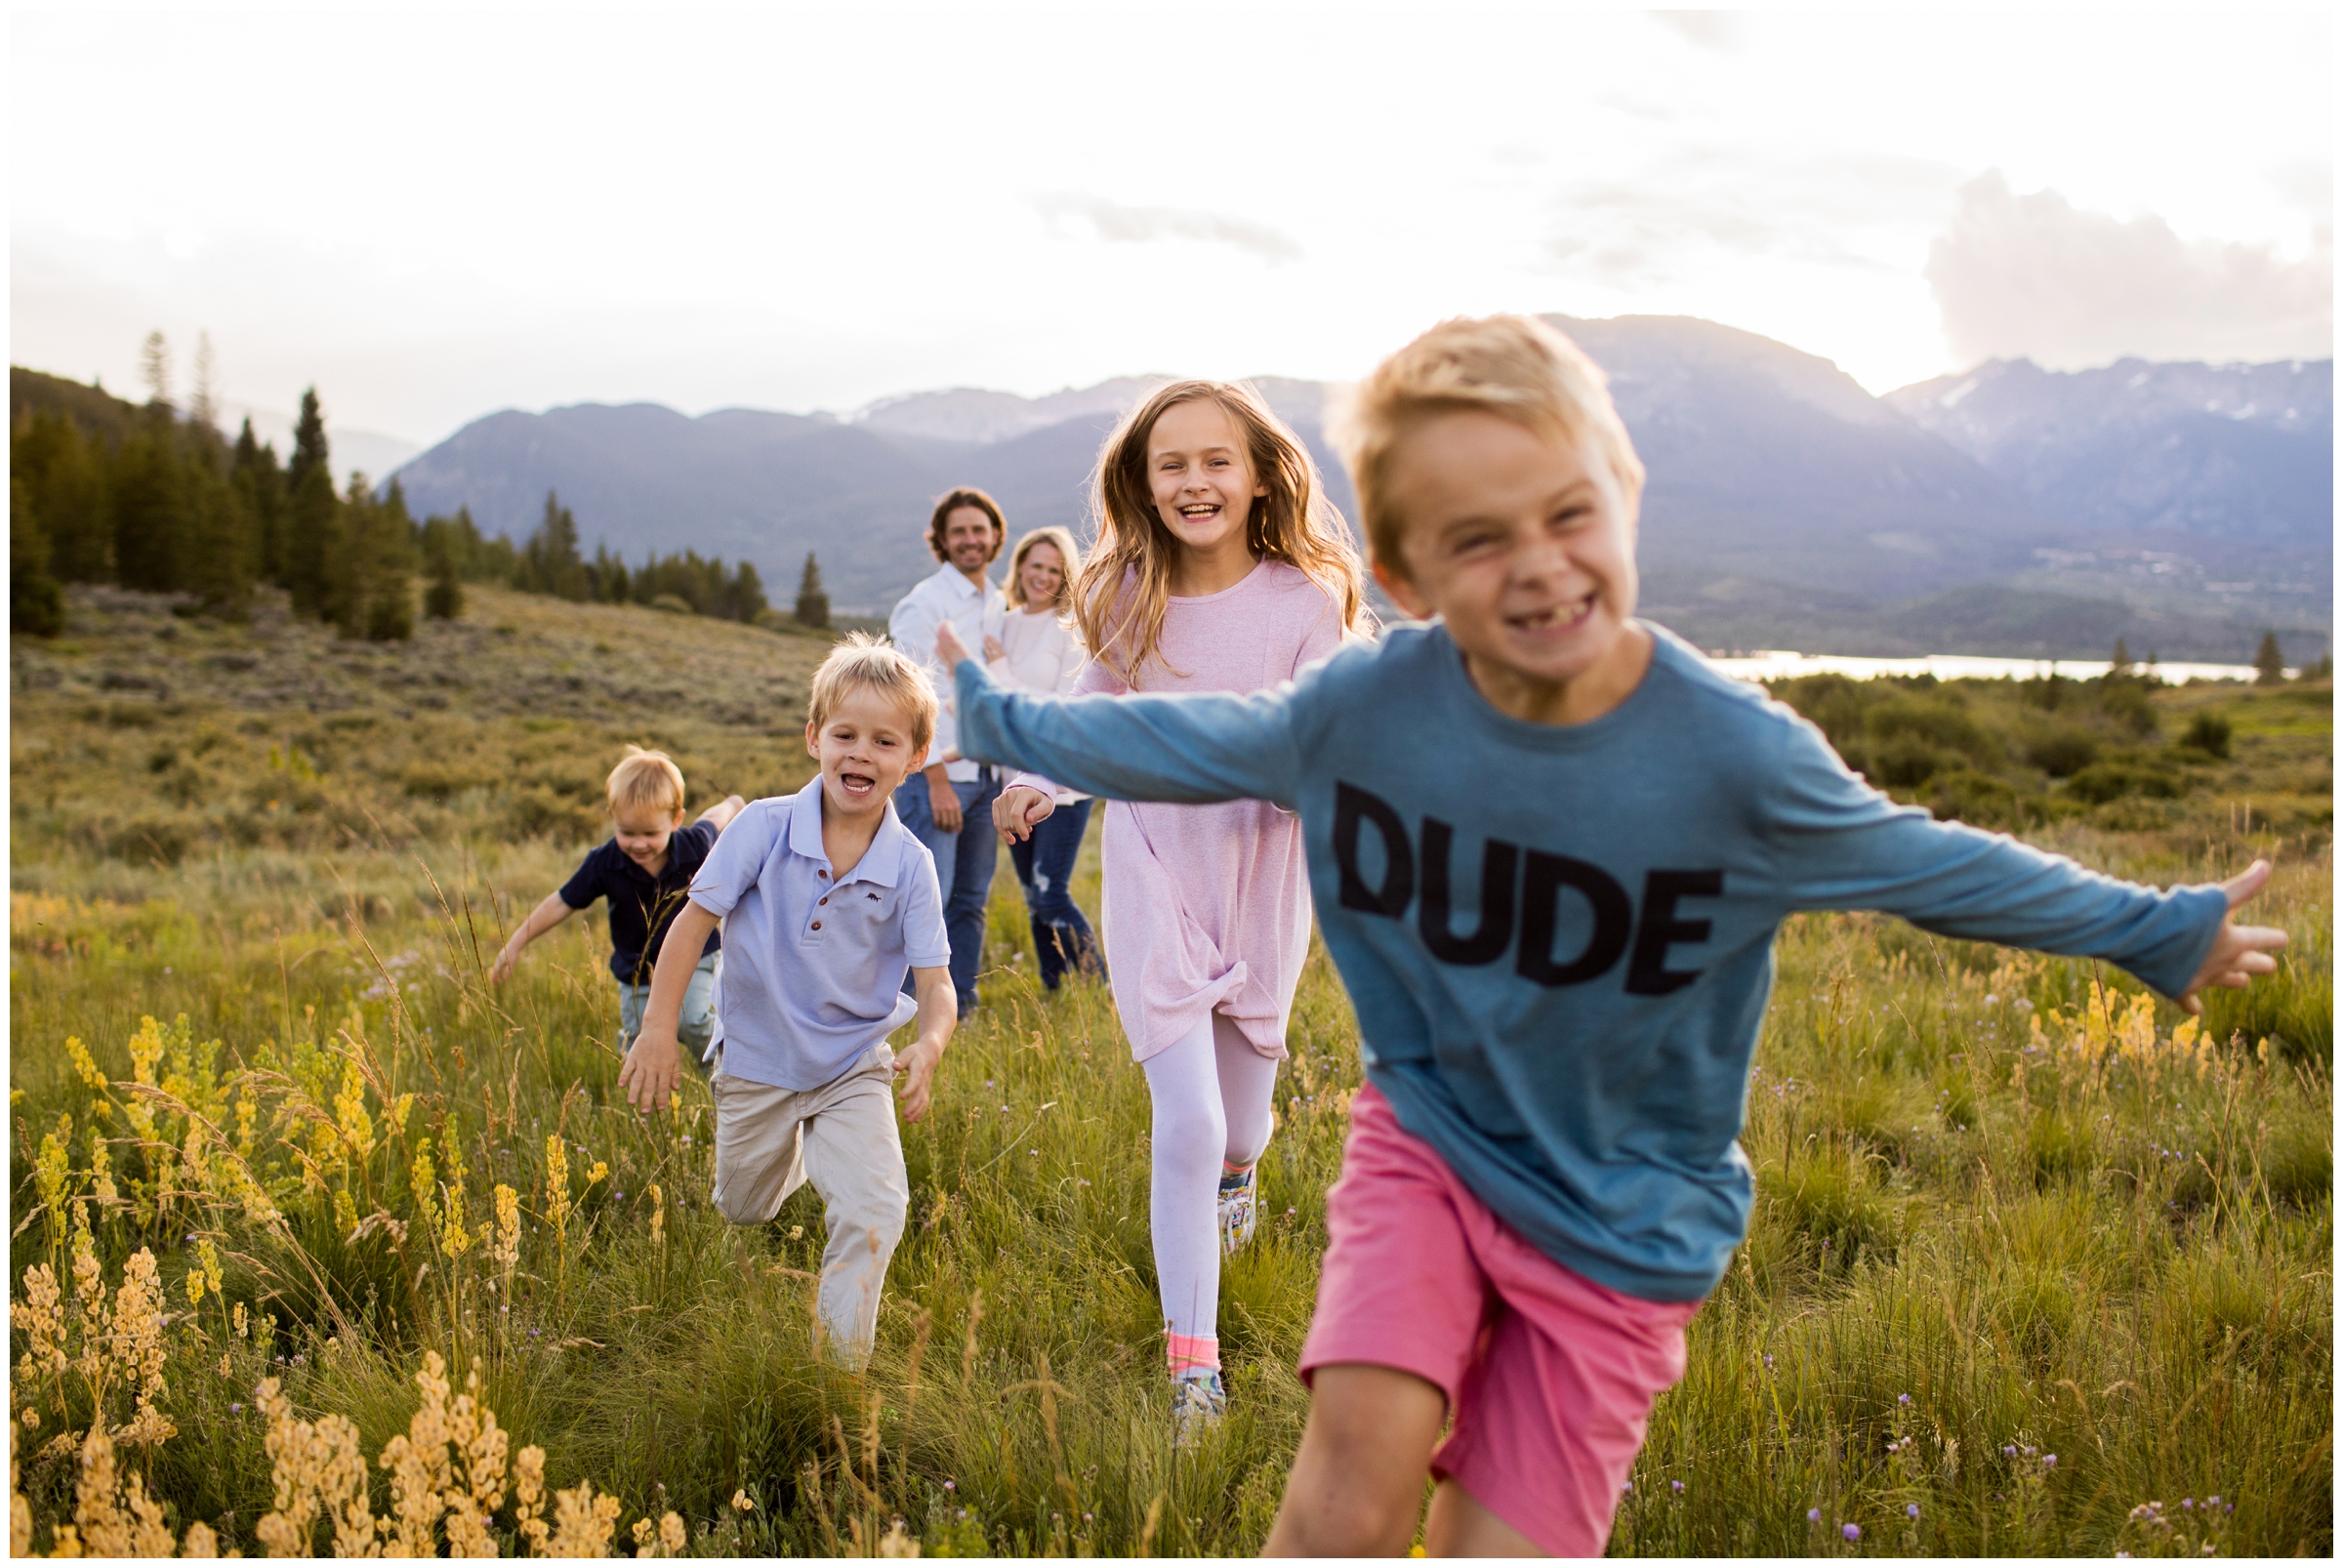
[[1009, 560, 1342, 1061]]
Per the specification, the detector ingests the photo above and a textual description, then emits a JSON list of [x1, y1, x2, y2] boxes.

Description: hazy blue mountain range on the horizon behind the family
[[384, 316, 2333, 661]]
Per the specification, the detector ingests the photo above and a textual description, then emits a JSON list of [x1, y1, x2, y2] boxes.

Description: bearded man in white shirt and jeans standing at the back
[[885, 487, 1007, 1017]]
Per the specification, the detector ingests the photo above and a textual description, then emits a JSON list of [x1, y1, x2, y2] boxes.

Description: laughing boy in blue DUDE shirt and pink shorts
[[937, 316, 2284, 1556]]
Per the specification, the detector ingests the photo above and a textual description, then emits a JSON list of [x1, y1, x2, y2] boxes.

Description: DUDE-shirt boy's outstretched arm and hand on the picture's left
[[935, 626, 1300, 811]]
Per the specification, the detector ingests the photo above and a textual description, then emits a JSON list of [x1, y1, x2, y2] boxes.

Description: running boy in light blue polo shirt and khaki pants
[[619, 633, 959, 1369]]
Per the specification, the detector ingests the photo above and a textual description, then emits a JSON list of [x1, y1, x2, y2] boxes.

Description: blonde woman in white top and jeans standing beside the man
[[984, 527, 1099, 991]]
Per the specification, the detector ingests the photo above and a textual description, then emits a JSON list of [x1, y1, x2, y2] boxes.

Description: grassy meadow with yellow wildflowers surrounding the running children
[[10, 591, 2333, 1556]]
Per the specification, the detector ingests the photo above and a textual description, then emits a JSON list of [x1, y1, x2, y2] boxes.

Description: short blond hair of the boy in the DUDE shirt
[[1331, 316, 1642, 577]]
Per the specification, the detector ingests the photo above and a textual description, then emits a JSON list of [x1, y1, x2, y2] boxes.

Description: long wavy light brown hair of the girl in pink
[[1073, 382, 1366, 686]]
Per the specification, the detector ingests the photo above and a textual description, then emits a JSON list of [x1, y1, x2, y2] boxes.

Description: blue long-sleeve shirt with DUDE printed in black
[[954, 624, 2228, 1300]]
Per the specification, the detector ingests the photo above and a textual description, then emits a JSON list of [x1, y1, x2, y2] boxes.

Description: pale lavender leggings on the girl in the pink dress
[[1143, 1012, 1277, 1371]]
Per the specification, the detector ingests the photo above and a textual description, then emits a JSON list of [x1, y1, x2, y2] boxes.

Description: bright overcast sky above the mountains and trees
[[10, 0, 2336, 443]]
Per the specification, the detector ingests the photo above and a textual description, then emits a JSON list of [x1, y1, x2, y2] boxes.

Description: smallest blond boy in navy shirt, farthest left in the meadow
[[487, 745, 740, 1061]]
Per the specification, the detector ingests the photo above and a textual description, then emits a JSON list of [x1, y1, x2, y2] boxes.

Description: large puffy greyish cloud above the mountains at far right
[[1926, 169, 2333, 370]]
